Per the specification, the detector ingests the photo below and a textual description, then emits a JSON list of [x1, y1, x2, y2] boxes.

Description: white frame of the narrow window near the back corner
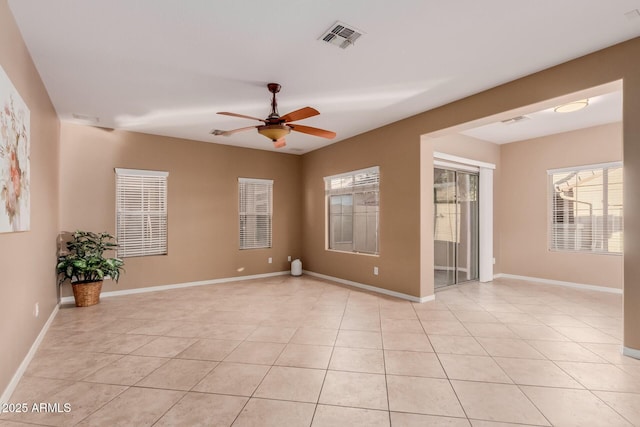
[[238, 177, 273, 251]]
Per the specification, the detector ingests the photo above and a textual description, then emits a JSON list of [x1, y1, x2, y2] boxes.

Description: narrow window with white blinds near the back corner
[[238, 178, 273, 249]]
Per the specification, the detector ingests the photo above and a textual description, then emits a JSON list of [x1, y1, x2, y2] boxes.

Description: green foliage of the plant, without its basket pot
[[56, 231, 124, 284]]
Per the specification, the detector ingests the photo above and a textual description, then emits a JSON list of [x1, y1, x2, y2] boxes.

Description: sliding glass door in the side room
[[433, 168, 478, 288]]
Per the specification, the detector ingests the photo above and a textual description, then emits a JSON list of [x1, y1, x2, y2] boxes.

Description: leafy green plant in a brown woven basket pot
[[56, 231, 124, 307]]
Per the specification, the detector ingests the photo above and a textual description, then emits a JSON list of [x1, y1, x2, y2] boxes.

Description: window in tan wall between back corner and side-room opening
[[324, 166, 380, 254]]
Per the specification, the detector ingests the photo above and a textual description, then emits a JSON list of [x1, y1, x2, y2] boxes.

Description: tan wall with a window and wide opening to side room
[[303, 38, 640, 349]]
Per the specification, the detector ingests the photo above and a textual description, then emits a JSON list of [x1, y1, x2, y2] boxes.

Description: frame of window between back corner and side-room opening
[[324, 166, 380, 256]]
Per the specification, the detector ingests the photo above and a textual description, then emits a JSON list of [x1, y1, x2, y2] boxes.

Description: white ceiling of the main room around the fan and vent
[[9, 0, 640, 154]]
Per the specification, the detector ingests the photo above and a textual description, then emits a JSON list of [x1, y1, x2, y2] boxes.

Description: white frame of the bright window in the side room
[[547, 161, 624, 256]]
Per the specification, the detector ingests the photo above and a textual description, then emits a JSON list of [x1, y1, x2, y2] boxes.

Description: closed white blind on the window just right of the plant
[[116, 168, 169, 258]]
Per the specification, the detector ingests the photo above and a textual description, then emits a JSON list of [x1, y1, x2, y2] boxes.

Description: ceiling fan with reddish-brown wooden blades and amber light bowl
[[210, 83, 336, 148]]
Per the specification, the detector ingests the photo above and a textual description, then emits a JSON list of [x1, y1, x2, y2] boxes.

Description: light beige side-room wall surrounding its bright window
[[496, 123, 623, 288]]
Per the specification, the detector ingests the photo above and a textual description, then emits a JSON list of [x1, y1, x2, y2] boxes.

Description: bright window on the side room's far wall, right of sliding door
[[548, 162, 623, 254]]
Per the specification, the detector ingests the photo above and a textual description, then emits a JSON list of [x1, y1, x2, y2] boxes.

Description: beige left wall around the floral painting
[[0, 0, 59, 395]]
